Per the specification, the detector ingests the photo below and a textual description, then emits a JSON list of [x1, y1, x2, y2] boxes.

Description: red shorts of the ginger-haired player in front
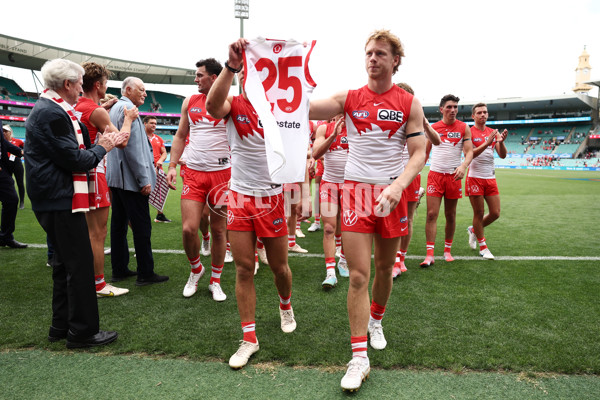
[[341, 181, 408, 238]]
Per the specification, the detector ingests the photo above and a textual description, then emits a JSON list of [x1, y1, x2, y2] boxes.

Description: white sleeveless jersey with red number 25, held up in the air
[[244, 38, 316, 183]]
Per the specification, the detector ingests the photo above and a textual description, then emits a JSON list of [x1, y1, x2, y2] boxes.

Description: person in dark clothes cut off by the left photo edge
[[0, 121, 27, 249]]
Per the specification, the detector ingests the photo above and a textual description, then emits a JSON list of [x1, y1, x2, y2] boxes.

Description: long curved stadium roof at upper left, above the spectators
[[0, 34, 196, 85]]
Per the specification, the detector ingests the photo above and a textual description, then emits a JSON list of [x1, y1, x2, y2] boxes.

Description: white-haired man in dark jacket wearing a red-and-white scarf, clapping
[[26, 59, 126, 348]]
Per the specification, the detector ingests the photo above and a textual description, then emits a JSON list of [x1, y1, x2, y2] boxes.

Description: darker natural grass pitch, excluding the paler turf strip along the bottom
[[0, 170, 600, 398]]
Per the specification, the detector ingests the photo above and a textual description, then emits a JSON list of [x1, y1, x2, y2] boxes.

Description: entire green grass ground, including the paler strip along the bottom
[[0, 170, 600, 398]]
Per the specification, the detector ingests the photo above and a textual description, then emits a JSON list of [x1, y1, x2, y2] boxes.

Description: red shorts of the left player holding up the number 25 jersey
[[227, 190, 287, 237]]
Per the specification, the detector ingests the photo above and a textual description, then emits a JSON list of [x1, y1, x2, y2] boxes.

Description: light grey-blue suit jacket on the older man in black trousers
[[106, 96, 156, 192]]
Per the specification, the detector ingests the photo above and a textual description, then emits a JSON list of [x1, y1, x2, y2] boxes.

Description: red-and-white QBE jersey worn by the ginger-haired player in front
[[344, 85, 413, 184]]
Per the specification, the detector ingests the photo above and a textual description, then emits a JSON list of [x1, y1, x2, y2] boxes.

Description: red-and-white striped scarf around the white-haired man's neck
[[41, 89, 96, 213]]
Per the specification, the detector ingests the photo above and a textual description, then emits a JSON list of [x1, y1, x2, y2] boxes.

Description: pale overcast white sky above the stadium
[[0, 0, 600, 103]]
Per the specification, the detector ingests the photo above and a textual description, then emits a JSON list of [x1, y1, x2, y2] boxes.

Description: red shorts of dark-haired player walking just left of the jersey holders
[[181, 168, 231, 207]]
